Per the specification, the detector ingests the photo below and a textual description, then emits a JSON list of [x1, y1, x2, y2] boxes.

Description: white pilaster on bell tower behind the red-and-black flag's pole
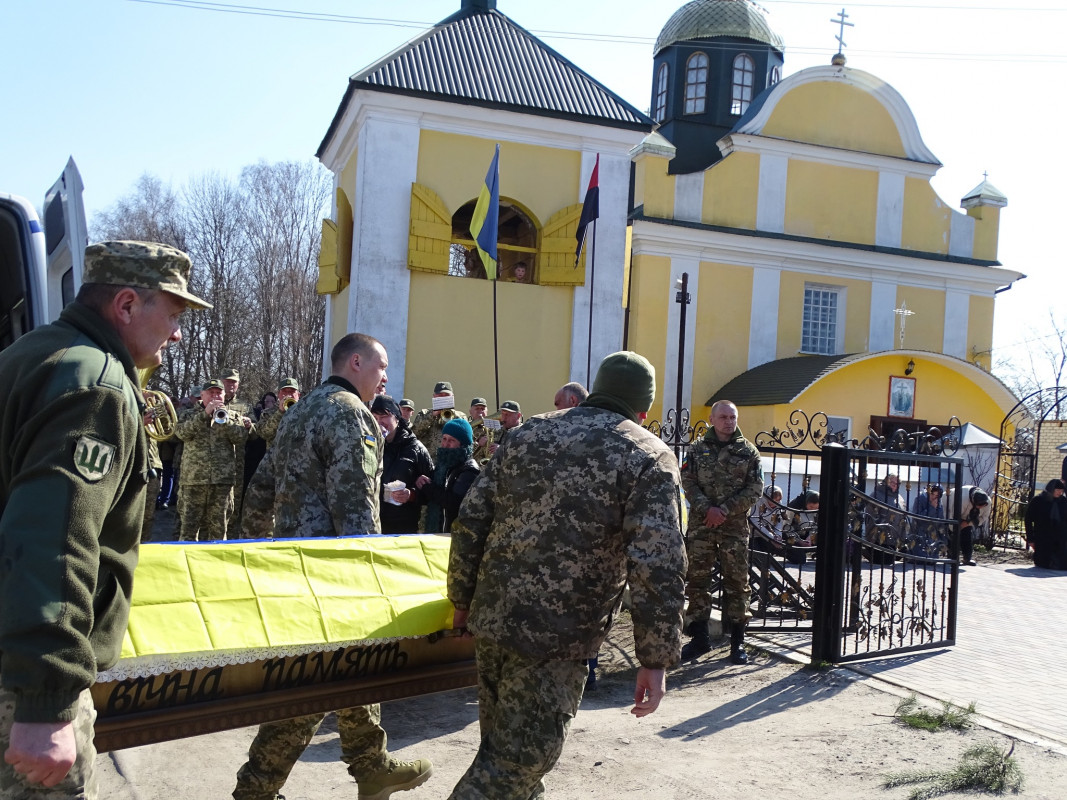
[[571, 153, 630, 391]]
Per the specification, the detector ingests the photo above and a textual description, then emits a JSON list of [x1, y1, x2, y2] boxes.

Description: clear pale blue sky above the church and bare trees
[[0, 0, 1067, 377]]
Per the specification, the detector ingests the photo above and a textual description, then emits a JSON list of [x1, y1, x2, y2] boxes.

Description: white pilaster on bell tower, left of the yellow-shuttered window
[[348, 115, 419, 397]]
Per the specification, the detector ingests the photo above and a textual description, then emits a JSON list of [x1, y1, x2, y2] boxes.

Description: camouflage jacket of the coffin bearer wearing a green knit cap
[[448, 406, 686, 669]]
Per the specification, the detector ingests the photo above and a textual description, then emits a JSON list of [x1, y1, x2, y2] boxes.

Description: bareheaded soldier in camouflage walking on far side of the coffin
[[234, 334, 433, 800]]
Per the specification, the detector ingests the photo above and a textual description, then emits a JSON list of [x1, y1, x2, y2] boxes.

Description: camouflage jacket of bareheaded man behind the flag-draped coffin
[[242, 375, 385, 539]]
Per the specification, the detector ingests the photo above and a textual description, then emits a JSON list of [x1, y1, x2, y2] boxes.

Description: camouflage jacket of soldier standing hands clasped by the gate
[[682, 428, 763, 531]]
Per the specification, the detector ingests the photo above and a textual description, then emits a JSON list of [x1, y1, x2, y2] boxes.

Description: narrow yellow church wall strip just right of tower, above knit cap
[[626, 255, 678, 419]]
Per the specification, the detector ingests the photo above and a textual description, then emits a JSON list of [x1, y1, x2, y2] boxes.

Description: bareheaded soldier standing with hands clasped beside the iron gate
[[682, 400, 763, 663]]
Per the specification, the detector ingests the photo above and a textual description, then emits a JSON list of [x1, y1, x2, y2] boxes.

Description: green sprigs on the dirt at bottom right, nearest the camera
[[882, 741, 1022, 800]]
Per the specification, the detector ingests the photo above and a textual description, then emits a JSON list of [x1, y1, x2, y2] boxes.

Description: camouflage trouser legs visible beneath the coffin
[[234, 703, 389, 800]]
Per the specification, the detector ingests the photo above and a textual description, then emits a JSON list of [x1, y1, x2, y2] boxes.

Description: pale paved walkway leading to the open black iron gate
[[751, 564, 1067, 753]]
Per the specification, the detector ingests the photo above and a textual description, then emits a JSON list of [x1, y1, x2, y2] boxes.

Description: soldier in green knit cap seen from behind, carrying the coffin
[[448, 353, 685, 800]]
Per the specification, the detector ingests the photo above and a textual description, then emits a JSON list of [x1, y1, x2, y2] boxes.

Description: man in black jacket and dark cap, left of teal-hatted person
[[370, 395, 433, 533]]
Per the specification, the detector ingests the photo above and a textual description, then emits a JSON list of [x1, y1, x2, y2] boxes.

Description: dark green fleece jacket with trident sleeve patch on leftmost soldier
[[0, 303, 148, 722]]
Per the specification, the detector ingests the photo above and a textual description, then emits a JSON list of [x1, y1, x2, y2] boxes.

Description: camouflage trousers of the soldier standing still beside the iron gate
[[685, 518, 752, 623]]
